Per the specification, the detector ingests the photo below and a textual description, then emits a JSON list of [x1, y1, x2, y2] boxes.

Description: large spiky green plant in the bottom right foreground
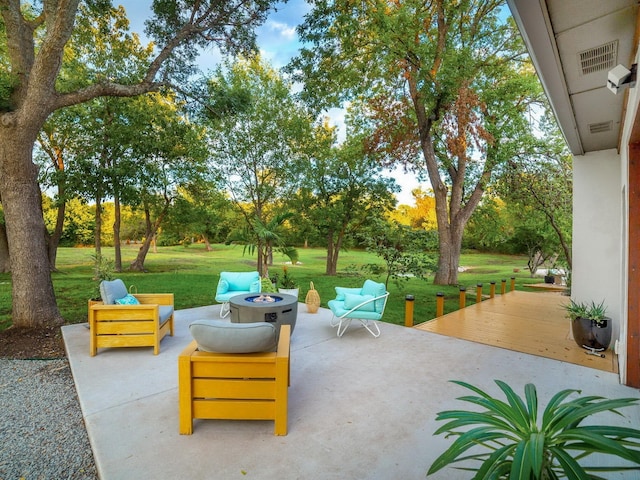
[[427, 380, 640, 480]]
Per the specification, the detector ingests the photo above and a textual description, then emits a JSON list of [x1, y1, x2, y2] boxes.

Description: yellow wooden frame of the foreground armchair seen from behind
[[178, 320, 291, 435]]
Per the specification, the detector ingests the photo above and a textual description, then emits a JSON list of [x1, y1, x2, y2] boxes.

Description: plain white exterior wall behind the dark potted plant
[[571, 150, 626, 347]]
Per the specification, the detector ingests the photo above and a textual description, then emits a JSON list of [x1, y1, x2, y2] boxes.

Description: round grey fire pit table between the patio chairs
[[229, 293, 298, 333]]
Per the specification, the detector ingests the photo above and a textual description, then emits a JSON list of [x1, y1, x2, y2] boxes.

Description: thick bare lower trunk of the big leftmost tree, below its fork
[[0, 130, 64, 328]]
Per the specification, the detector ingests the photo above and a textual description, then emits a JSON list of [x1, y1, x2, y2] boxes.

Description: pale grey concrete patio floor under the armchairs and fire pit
[[63, 304, 640, 480]]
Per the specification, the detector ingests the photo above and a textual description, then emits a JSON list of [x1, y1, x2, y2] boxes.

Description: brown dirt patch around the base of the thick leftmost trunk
[[0, 327, 66, 360]]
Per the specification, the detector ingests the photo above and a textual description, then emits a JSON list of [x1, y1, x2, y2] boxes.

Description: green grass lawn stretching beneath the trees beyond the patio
[[0, 244, 542, 330]]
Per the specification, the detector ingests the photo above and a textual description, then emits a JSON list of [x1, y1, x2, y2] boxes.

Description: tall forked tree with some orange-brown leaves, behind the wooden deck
[[290, 0, 541, 284]]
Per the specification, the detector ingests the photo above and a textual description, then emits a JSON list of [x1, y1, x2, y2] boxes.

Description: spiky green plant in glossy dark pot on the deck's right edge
[[565, 300, 611, 352]]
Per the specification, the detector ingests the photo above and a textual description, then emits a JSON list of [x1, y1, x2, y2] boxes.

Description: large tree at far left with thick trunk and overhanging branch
[[0, 0, 273, 327]]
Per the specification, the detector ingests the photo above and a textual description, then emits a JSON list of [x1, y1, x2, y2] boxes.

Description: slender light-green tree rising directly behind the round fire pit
[[205, 57, 312, 275]]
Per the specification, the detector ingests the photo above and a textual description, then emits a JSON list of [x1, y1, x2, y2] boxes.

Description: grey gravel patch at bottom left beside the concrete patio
[[0, 359, 98, 480]]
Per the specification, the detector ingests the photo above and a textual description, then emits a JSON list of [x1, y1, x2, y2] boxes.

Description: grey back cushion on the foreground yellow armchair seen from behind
[[189, 320, 277, 353]]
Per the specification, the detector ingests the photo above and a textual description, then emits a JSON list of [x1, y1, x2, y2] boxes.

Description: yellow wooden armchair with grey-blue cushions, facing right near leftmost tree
[[89, 279, 173, 357]]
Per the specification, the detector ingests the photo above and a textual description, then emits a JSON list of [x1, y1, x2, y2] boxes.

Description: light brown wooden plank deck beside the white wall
[[415, 290, 618, 373]]
